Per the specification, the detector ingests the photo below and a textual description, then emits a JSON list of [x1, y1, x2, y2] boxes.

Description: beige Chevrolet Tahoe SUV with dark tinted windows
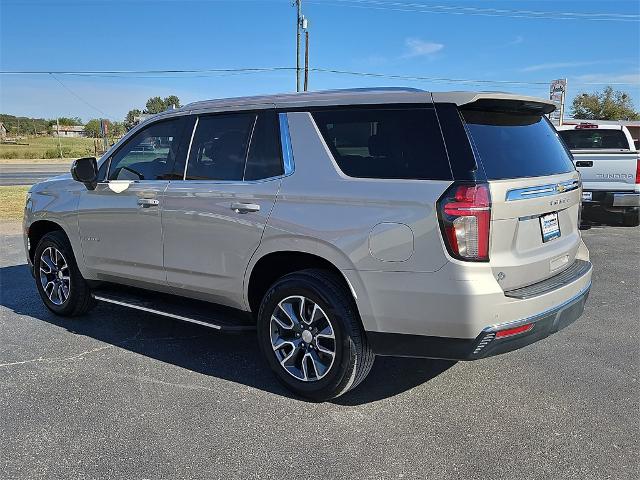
[[24, 89, 592, 400]]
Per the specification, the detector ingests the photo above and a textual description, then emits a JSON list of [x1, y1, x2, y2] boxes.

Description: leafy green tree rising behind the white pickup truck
[[571, 86, 640, 120]]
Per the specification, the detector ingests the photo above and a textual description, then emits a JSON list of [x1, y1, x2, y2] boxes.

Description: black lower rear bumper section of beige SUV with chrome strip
[[367, 282, 591, 360]]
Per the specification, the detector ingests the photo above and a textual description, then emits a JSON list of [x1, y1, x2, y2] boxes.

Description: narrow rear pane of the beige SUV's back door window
[[244, 112, 284, 180]]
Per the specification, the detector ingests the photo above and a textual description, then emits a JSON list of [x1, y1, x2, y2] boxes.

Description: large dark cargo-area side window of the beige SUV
[[313, 108, 451, 180]]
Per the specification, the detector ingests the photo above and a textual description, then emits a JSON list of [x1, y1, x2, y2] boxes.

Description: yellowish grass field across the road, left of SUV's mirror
[[0, 137, 94, 159]]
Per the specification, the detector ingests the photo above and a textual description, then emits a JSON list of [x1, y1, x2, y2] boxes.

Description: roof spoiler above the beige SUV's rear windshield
[[432, 92, 556, 115]]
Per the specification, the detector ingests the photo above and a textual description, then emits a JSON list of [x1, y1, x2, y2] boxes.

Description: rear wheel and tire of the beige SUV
[[258, 269, 375, 401]]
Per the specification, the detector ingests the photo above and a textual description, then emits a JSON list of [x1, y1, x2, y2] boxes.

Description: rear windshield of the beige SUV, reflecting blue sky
[[461, 110, 575, 180]]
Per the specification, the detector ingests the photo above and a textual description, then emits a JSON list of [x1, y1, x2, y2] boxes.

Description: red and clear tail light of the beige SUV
[[438, 183, 491, 262]]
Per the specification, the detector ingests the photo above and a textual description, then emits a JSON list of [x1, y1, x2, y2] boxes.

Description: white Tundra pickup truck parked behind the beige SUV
[[557, 122, 640, 226]]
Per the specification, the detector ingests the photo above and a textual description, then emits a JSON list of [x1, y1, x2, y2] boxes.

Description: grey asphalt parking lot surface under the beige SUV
[[0, 223, 640, 479]]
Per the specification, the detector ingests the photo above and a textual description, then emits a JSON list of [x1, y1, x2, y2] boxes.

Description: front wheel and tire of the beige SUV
[[33, 231, 95, 317]]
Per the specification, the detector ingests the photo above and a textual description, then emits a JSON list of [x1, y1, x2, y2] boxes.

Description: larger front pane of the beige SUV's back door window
[[187, 113, 256, 180]]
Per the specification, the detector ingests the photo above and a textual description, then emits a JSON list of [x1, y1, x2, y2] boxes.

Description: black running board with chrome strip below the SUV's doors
[[93, 287, 256, 332]]
